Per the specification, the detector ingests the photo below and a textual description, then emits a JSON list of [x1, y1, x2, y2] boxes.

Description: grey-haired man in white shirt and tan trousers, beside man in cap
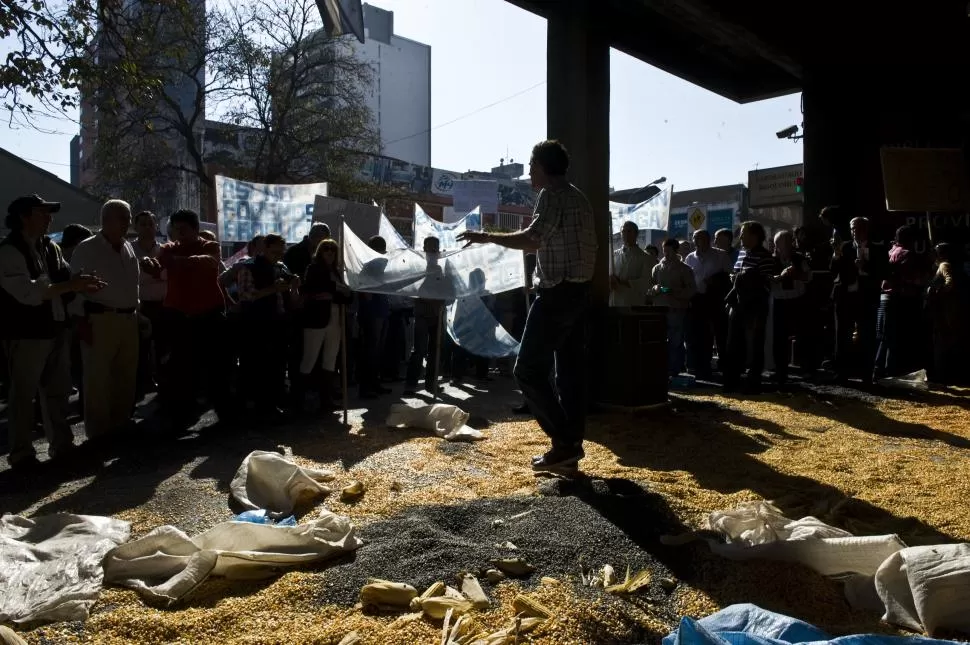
[[72, 199, 147, 439]]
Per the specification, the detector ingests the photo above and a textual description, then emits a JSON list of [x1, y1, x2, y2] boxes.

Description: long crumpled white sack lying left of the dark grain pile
[[104, 511, 362, 603]]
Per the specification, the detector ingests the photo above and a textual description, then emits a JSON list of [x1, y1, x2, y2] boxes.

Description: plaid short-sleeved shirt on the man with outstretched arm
[[527, 184, 597, 288]]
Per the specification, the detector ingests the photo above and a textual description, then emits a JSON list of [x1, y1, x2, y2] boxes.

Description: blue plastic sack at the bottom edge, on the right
[[663, 604, 965, 645]]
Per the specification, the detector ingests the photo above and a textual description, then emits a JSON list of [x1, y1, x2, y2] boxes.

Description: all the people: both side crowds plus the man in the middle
[[0, 141, 970, 471]]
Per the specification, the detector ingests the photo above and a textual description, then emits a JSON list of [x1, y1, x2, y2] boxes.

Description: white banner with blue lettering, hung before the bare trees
[[215, 175, 327, 242]]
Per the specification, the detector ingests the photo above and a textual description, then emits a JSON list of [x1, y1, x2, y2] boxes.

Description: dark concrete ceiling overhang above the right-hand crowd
[[508, 0, 970, 103]]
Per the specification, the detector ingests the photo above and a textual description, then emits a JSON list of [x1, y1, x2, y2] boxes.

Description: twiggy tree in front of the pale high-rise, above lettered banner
[[216, 0, 380, 194]]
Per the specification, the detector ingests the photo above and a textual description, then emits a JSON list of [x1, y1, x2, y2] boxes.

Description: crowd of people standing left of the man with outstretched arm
[[0, 189, 521, 468]]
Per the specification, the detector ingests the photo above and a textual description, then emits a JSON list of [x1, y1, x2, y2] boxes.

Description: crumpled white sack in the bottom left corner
[[0, 514, 131, 623]]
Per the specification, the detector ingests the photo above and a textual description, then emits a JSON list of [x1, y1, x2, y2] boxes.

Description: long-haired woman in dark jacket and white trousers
[[297, 239, 352, 409]]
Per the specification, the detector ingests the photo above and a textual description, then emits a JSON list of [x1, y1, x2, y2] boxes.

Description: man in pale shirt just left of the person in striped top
[[684, 230, 733, 379]]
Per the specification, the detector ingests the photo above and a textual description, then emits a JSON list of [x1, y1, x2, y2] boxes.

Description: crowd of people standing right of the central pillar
[[611, 207, 970, 393]]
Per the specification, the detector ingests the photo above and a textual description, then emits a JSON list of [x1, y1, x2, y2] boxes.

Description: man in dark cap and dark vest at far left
[[0, 195, 104, 468]]
